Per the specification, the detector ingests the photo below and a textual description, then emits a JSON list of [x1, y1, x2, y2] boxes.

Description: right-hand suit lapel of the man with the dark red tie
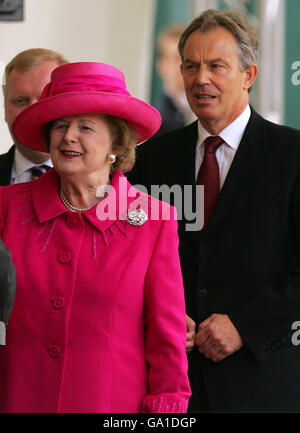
[[205, 109, 271, 235]]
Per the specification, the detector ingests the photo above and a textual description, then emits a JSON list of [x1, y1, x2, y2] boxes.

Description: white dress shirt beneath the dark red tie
[[195, 105, 251, 189]]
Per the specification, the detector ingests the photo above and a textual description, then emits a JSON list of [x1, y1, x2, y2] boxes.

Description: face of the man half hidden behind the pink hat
[[5, 60, 59, 162]]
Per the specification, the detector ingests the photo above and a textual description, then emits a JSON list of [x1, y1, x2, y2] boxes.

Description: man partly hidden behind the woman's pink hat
[[0, 48, 67, 185]]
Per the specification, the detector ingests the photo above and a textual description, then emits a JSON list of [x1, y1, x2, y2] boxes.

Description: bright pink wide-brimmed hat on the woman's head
[[12, 62, 161, 152]]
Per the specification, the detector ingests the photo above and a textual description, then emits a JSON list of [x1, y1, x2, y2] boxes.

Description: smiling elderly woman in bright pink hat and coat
[[0, 63, 190, 412]]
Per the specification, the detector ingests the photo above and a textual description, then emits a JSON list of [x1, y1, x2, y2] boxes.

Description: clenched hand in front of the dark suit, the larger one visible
[[195, 314, 244, 361]]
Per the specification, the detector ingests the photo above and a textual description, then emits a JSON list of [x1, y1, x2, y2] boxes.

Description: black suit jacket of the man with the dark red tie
[[128, 110, 300, 412]]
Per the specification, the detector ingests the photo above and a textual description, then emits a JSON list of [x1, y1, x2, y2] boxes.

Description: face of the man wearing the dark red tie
[[182, 27, 257, 134]]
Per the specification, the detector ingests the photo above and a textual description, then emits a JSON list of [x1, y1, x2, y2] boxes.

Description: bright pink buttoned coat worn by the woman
[[0, 170, 190, 413]]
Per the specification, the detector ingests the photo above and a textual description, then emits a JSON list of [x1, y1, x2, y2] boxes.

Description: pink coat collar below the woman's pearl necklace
[[32, 169, 141, 232]]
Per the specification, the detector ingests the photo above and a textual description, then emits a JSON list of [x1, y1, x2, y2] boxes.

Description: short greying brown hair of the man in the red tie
[[178, 9, 258, 72]]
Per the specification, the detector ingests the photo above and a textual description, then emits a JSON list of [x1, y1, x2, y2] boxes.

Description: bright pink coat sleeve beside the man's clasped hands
[[142, 208, 191, 413]]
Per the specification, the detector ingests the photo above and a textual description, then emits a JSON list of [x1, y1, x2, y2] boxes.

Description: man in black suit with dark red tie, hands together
[[128, 10, 300, 412]]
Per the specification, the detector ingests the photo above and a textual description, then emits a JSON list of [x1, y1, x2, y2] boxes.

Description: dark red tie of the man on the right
[[197, 136, 223, 230]]
